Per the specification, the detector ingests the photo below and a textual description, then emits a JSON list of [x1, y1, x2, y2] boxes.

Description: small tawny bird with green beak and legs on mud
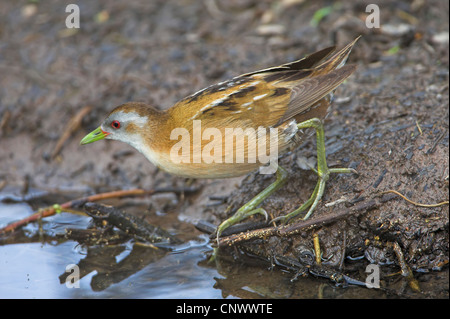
[[80, 37, 359, 239]]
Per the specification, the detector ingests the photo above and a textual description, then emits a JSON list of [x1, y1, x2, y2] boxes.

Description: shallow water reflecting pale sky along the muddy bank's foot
[[0, 203, 448, 299]]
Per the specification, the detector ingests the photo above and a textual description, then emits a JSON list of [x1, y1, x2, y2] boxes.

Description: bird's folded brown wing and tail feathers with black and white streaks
[[169, 39, 358, 129]]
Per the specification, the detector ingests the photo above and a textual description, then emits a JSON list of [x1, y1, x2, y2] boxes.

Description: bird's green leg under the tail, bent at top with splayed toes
[[273, 118, 356, 223]]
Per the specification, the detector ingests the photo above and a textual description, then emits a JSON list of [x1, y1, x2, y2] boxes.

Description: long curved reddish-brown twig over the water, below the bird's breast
[[0, 188, 198, 234]]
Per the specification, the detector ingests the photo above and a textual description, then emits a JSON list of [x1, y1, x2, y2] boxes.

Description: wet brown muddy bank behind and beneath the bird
[[0, 0, 449, 298]]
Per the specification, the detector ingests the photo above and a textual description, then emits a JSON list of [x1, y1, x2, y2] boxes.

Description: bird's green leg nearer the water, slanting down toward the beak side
[[217, 166, 287, 238]]
